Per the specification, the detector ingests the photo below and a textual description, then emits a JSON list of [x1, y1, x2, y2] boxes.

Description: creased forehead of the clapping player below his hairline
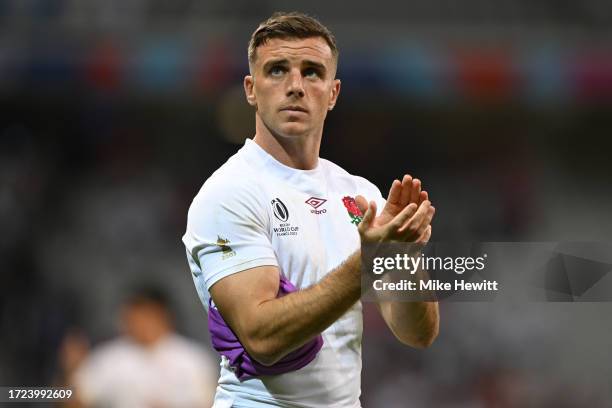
[[256, 37, 333, 64]]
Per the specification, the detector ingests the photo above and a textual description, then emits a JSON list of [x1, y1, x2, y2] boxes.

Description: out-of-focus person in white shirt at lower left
[[60, 289, 218, 408]]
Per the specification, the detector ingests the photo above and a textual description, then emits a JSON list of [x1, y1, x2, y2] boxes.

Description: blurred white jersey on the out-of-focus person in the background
[[74, 334, 217, 408]]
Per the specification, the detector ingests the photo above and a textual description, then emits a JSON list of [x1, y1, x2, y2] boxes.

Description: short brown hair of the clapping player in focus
[[249, 11, 339, 64]]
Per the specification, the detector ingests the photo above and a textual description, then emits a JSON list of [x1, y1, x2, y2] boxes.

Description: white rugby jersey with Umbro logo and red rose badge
[[183, 139, 384, 408]]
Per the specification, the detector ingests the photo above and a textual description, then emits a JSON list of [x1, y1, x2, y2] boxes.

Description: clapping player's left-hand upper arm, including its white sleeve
[[183, 178, 280, 355]]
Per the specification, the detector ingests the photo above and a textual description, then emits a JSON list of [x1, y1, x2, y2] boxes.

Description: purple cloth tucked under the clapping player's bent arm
[[208, 275, 323, 381]]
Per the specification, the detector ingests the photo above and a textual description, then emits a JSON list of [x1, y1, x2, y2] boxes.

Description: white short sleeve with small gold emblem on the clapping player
[[183, 179, 278, 290]]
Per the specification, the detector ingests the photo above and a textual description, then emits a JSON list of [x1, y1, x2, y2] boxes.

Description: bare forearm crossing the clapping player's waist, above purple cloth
[[248, 252, 361, 364]]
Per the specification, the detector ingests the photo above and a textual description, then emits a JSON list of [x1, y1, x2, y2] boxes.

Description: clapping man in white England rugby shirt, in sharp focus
[[183, 13, 438, 407]]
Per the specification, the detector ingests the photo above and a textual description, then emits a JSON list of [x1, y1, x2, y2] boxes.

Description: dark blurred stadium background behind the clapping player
[[0, 0, 612, 407]]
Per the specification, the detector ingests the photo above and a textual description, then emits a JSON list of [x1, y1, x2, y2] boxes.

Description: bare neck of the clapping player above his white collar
[[253, 114, 323, 170]]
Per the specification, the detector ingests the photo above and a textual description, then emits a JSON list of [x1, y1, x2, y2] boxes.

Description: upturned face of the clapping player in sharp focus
[[244, 37, 340, 137]]
